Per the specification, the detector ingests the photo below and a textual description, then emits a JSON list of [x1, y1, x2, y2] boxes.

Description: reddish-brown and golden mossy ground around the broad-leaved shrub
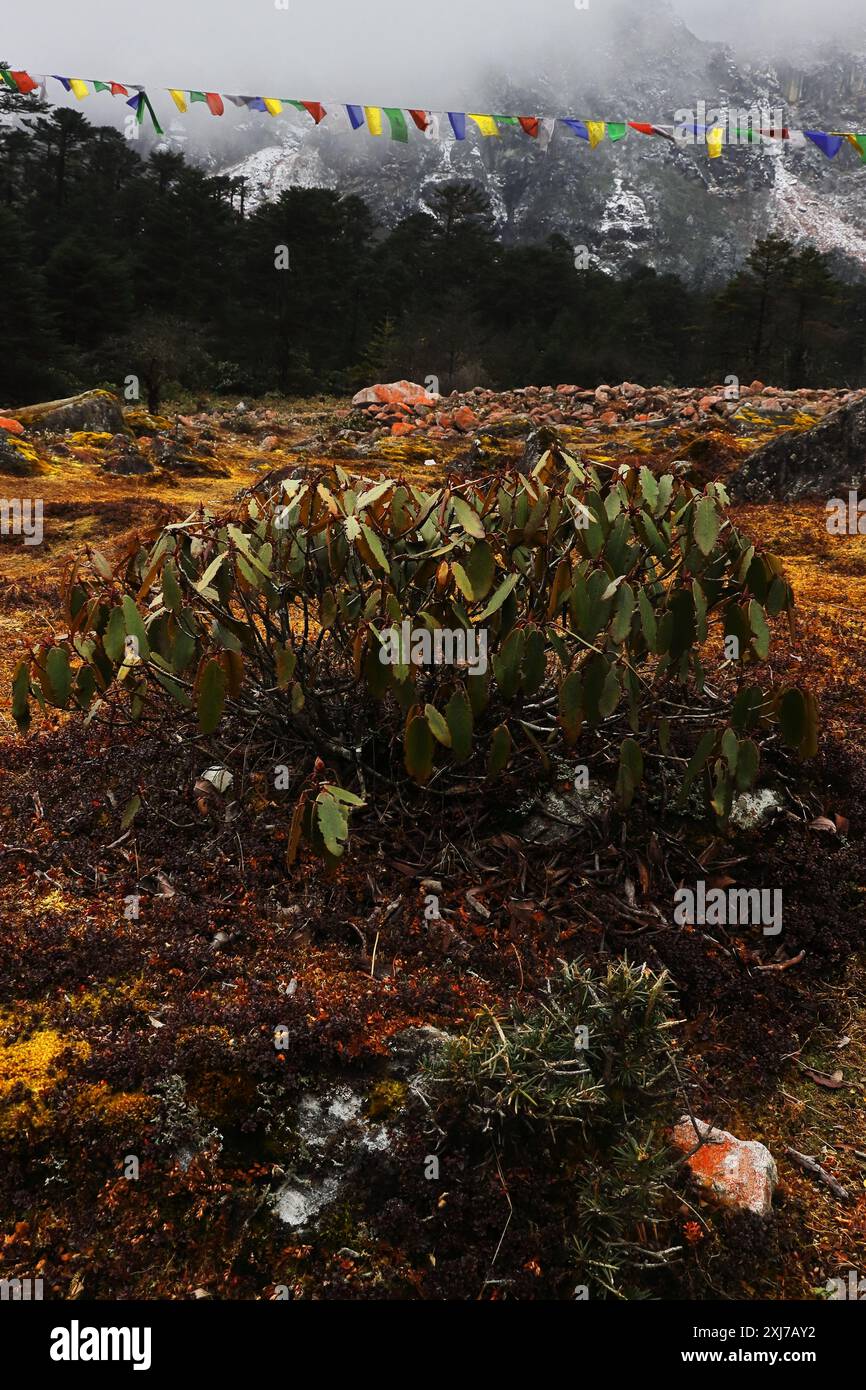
[[0, 402, 866, 1300]]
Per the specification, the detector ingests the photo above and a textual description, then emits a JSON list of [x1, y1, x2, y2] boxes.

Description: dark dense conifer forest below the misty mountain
[[0, 93, 866, 406]]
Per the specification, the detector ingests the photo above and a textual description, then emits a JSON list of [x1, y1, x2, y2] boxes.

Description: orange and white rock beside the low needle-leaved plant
[[671, 1115, 778, 1216]]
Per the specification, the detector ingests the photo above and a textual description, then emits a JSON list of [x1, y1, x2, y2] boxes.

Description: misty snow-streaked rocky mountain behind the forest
[[170, 0, 866, 284]]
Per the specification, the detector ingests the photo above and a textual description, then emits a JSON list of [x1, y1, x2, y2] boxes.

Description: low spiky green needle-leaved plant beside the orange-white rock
[[427, 960, 683, 1298]]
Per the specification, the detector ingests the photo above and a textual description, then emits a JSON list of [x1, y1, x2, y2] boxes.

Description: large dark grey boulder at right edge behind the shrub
[[730, 396, 866, 502]]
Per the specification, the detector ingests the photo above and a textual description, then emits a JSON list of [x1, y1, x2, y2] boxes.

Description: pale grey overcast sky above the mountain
[[0, 0, 866, 110]]
